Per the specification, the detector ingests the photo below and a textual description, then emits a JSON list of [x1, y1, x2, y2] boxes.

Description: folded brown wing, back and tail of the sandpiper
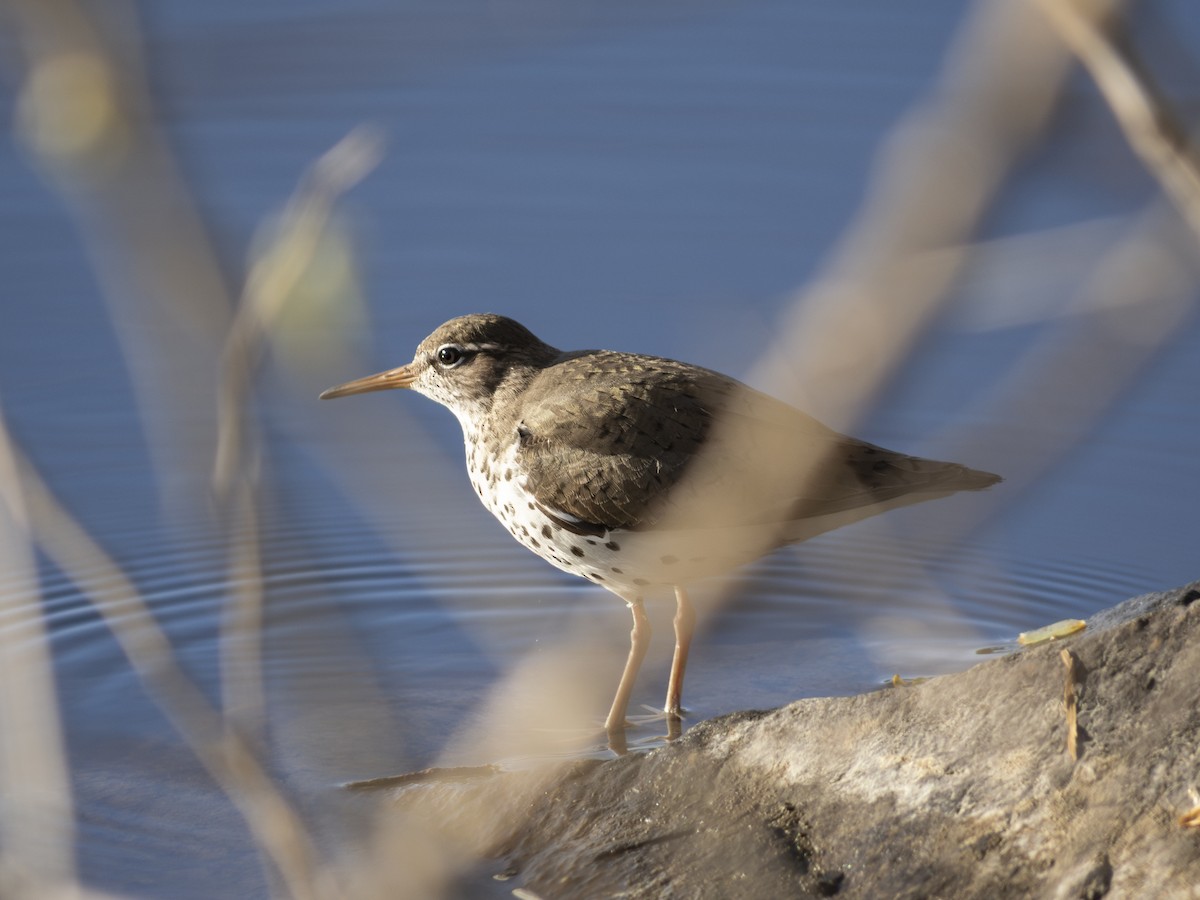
[[506, 352, 997, 532]]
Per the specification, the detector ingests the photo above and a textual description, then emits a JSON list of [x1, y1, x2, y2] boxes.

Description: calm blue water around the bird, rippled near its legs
[[0, 0, 1200, 898]]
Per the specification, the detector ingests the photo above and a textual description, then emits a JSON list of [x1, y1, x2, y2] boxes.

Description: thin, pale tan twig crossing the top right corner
[[1037, 0, 1200, 238]]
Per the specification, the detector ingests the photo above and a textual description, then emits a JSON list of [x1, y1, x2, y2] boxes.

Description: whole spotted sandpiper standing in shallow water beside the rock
[[320, 314, 1000, 734]]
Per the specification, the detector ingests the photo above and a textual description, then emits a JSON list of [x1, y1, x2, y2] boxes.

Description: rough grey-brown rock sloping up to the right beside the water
[[462, 582, 1200, 898]]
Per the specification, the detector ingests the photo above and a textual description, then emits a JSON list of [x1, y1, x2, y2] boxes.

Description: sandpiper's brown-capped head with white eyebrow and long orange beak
[[320, 313, 560, 420]]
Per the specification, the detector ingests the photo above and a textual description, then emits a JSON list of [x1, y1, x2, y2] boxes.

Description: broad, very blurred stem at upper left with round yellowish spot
[[0, 0, 233, 516]]
